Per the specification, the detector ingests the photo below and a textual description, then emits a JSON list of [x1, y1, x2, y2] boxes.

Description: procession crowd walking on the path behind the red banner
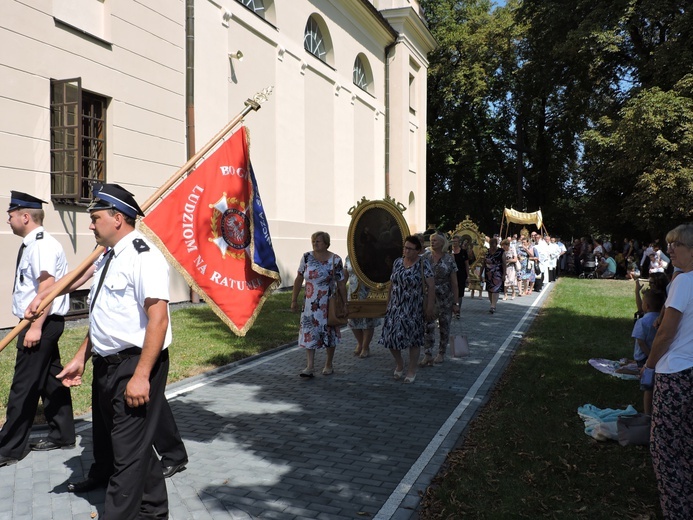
[[291, 231, 559, 384]]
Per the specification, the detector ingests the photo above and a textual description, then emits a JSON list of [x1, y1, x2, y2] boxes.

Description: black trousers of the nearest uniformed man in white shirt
[[92, 349, 169, 520]]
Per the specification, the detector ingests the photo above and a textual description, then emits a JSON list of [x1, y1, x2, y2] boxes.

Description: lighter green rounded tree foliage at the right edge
[[584, 74, 693, 237]]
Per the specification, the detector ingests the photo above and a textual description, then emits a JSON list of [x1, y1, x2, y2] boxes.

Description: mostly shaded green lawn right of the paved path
[[420, 278, 660, 520]]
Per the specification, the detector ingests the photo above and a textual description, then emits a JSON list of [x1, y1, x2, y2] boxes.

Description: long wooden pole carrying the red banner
[[0, 87, 273, 352]]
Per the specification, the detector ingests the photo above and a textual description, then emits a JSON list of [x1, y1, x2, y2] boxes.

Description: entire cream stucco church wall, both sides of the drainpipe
[[0, 0, 432, 327]]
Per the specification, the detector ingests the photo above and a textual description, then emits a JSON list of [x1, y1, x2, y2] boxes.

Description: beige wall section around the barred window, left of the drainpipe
[[0, 0, 188, 327]]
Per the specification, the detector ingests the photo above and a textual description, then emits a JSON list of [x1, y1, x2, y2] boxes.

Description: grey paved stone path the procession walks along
[[0, 284, 553, 520]]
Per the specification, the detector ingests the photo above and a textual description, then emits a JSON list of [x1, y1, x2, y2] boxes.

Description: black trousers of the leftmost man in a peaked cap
[[0, 315, 75, 459]]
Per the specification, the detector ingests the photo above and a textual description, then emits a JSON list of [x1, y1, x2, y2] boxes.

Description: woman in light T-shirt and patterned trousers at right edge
[[643, 224, 693, 519]]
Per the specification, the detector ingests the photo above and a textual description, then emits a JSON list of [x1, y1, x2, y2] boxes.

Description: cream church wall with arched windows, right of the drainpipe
[[195, 0, 427, 285]]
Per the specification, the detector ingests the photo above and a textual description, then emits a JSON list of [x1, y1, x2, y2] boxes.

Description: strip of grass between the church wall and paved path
[[0, 292, 298, 423]]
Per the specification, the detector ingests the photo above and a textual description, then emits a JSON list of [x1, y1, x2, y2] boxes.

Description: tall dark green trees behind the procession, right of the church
[[422, 0, 693, 240]]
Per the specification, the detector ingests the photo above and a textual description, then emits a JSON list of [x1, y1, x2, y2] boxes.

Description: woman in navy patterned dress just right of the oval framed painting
[[378, 236, 435, 383]]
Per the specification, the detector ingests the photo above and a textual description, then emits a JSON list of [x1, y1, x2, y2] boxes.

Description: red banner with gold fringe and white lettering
[[141, 127, 281, 336]]
